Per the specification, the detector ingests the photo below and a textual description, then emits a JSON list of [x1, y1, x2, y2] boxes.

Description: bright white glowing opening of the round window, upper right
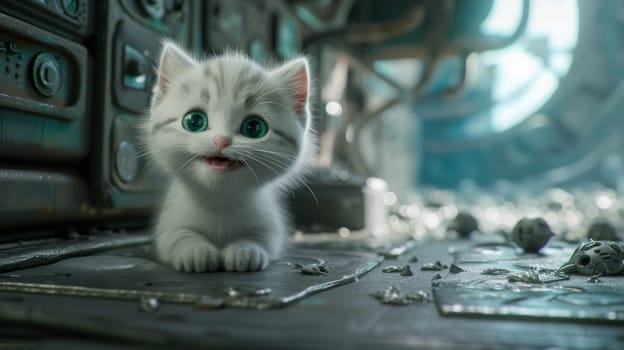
[[480, 0, 579, 132]]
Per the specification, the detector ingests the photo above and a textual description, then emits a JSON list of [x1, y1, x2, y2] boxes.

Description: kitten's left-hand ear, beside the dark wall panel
[[154, 41, 197, 96]]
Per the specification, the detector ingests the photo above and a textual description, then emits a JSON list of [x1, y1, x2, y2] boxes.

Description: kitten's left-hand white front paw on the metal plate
[[171, 240, 219, 272]]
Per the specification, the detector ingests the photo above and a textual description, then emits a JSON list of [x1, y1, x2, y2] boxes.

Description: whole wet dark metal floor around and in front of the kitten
[[0, 235, 624, 349]]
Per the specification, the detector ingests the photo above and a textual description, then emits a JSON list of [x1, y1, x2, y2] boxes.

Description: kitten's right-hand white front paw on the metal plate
[[223, 242, 269, 272]]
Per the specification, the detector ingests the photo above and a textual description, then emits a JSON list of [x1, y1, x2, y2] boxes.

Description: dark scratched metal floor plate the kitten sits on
[[0, 247, 383, 309]]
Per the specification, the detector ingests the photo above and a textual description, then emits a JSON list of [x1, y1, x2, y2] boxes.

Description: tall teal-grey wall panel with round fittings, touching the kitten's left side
[[90, 0, 196, 210]]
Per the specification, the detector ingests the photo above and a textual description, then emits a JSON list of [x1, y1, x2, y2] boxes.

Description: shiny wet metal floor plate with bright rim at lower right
[[434, 279, 624, 322]]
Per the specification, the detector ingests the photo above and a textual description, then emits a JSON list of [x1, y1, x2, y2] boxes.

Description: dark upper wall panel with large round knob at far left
[[0, 13, 89, 162]]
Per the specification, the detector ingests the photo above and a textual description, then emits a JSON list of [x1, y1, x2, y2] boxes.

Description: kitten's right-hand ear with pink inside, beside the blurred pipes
[[271, 58, 310, 114]]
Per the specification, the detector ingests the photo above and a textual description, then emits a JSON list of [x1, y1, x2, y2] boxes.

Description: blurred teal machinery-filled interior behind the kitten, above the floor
[[0, 0, 624, 239]]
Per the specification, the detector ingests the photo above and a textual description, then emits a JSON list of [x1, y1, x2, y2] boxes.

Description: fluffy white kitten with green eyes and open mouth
[[143, 42, 313, 272]]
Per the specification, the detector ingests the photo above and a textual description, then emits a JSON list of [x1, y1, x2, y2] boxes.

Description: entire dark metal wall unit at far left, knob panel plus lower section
[[0, 9, 92, 227]]
